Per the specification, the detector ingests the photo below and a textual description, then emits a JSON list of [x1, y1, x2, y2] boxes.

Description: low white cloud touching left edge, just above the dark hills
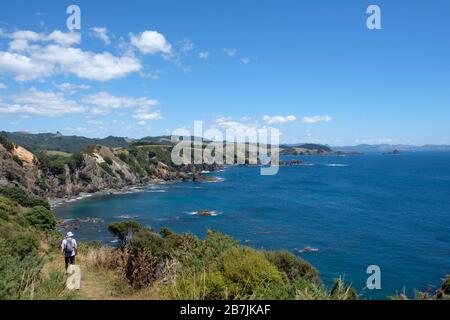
[[0, 88, 86, 116]]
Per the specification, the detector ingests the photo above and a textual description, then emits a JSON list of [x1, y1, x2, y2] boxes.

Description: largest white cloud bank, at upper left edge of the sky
[[0, 30, 142, 81]]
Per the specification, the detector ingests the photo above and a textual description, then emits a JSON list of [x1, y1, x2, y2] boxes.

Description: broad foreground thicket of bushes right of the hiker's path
[[98, 221, 357, 299]]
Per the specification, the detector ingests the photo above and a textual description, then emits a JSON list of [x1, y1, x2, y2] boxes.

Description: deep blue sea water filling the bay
[[56, 153, 450, 298]]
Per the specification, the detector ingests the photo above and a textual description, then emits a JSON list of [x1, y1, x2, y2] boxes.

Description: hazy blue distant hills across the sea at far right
[[333, 144, 450, 153]]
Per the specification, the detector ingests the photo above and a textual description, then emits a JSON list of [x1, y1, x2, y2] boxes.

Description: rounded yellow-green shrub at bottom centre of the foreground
[[166, 247, 288, 300]]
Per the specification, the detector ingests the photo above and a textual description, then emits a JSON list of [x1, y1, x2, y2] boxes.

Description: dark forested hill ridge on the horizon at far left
[[2, 132, 133, 153]]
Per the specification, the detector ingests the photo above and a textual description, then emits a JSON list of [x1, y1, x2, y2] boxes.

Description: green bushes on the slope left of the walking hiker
[[0, 193, 79, 300]]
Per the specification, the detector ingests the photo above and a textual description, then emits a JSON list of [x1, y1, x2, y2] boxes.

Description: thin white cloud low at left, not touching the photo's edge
[[82, 92, 158, 114]]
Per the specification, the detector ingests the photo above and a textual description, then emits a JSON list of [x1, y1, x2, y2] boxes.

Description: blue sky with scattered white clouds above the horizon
[[0, 0, 450, 145]]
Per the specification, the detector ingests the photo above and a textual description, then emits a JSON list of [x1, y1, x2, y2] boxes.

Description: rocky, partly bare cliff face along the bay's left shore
[[0, 144, 204, 198]]
